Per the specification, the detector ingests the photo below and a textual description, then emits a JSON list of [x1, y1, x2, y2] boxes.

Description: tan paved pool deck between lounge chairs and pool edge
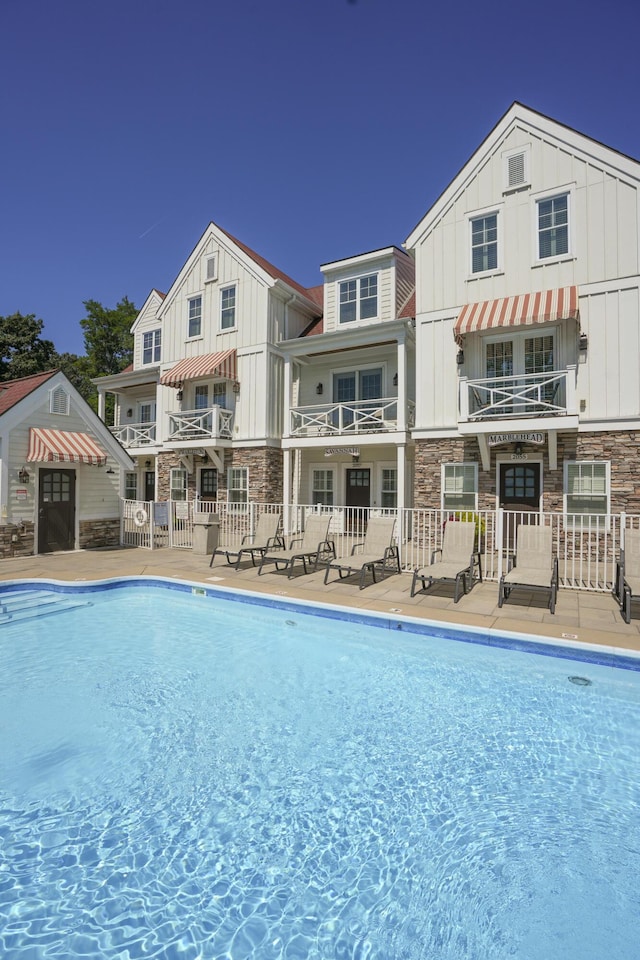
[[0, 547, 640, 652]]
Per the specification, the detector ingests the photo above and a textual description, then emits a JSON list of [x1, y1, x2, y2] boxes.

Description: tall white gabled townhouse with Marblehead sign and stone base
[[405, 103, 640, 515]]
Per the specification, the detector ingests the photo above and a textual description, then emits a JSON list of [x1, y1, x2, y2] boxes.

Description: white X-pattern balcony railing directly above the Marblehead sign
[[460, 367, 575, 421]]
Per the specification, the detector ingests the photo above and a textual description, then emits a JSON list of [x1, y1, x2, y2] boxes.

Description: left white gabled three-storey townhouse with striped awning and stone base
[[95, 223, 322, 503]]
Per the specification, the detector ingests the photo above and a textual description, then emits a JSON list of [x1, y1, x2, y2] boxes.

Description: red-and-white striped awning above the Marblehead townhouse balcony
[[453, 287, 580, 345]]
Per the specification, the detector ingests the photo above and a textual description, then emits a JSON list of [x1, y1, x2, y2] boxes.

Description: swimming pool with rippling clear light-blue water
[[0, 581, 640, 960]]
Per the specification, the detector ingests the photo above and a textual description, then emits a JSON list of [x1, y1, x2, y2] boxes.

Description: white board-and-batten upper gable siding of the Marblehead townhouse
[[416, 128, 640, 312]]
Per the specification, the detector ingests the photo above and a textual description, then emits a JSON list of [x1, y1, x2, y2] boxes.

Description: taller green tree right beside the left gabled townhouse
[[80, 297, 138, 377]]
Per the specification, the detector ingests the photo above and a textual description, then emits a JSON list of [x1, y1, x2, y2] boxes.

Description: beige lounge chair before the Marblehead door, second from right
[[498, 524, 558, 613]]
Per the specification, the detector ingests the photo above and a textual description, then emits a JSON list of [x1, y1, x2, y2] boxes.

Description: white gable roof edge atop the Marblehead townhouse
[[403, 100, 640, 249]]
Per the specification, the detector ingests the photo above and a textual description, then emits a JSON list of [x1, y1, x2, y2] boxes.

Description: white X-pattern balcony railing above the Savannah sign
[[291, 397, 415, 437]]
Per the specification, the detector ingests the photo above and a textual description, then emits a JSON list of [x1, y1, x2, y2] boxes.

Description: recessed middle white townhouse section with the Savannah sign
[[280, 246, 415, 510]]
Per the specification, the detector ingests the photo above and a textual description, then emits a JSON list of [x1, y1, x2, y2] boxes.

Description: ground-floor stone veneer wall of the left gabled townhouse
[[157, 447, 283, 503]]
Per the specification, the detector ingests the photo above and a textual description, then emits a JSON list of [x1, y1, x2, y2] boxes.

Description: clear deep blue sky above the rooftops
[[0, 0, 640, 353]]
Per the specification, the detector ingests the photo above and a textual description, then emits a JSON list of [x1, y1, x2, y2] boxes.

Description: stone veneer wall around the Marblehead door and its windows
[[414, 431, 640, 514]]
